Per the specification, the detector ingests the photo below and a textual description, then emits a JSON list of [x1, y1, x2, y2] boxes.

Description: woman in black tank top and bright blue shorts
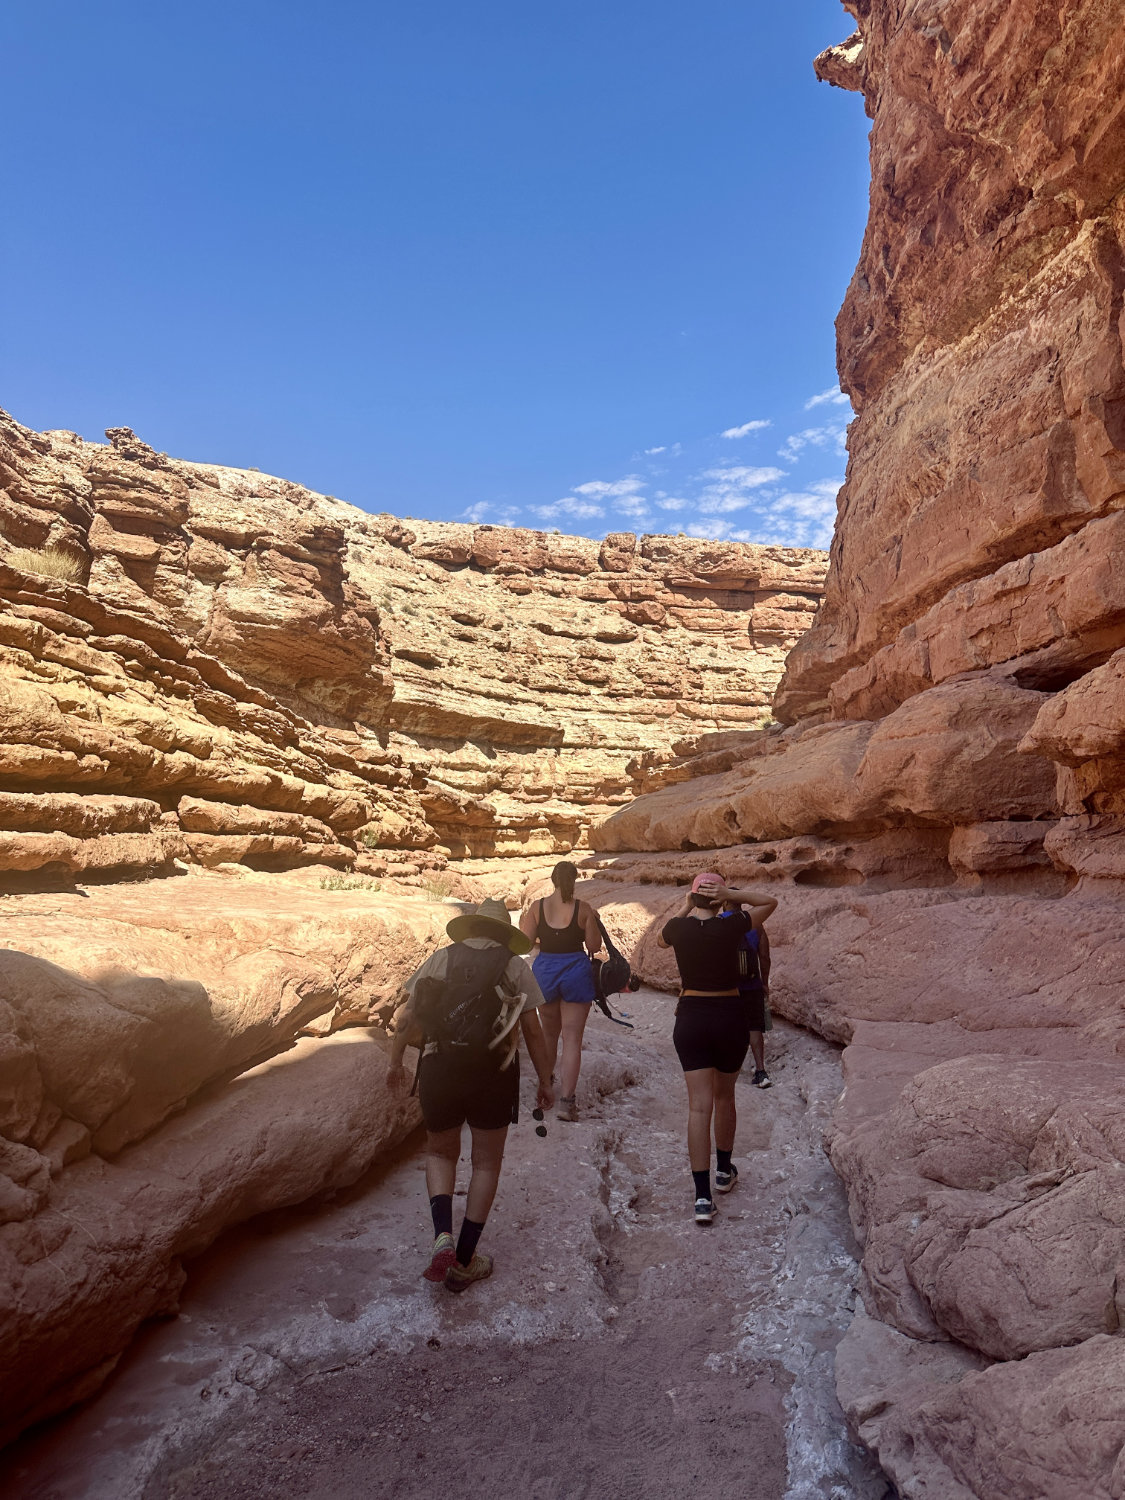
[[519, 860, 602, 1121]]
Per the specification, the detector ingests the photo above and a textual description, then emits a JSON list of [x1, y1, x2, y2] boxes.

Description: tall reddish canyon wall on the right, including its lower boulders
[[588, 0, 1125, 1500]]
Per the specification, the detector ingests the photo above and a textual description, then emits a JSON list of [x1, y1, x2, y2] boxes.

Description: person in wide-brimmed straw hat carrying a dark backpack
[[387, 900, 555, 1292]]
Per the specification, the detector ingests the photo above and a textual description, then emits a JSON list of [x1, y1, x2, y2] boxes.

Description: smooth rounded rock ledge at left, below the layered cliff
[[0, 873, 450, 1442]]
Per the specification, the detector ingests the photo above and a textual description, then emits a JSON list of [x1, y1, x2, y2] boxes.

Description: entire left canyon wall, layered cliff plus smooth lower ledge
[[0, 414, 827, 1442]]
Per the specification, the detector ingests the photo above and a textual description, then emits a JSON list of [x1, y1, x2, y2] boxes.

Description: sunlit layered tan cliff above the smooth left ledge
[[0, 417, 825, 876]]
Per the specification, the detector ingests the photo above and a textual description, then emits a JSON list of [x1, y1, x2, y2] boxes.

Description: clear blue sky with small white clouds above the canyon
[[0, 0, 867, 545]]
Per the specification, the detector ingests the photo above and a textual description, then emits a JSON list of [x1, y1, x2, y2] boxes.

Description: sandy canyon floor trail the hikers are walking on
[[0, 992, 893, 1500]]
